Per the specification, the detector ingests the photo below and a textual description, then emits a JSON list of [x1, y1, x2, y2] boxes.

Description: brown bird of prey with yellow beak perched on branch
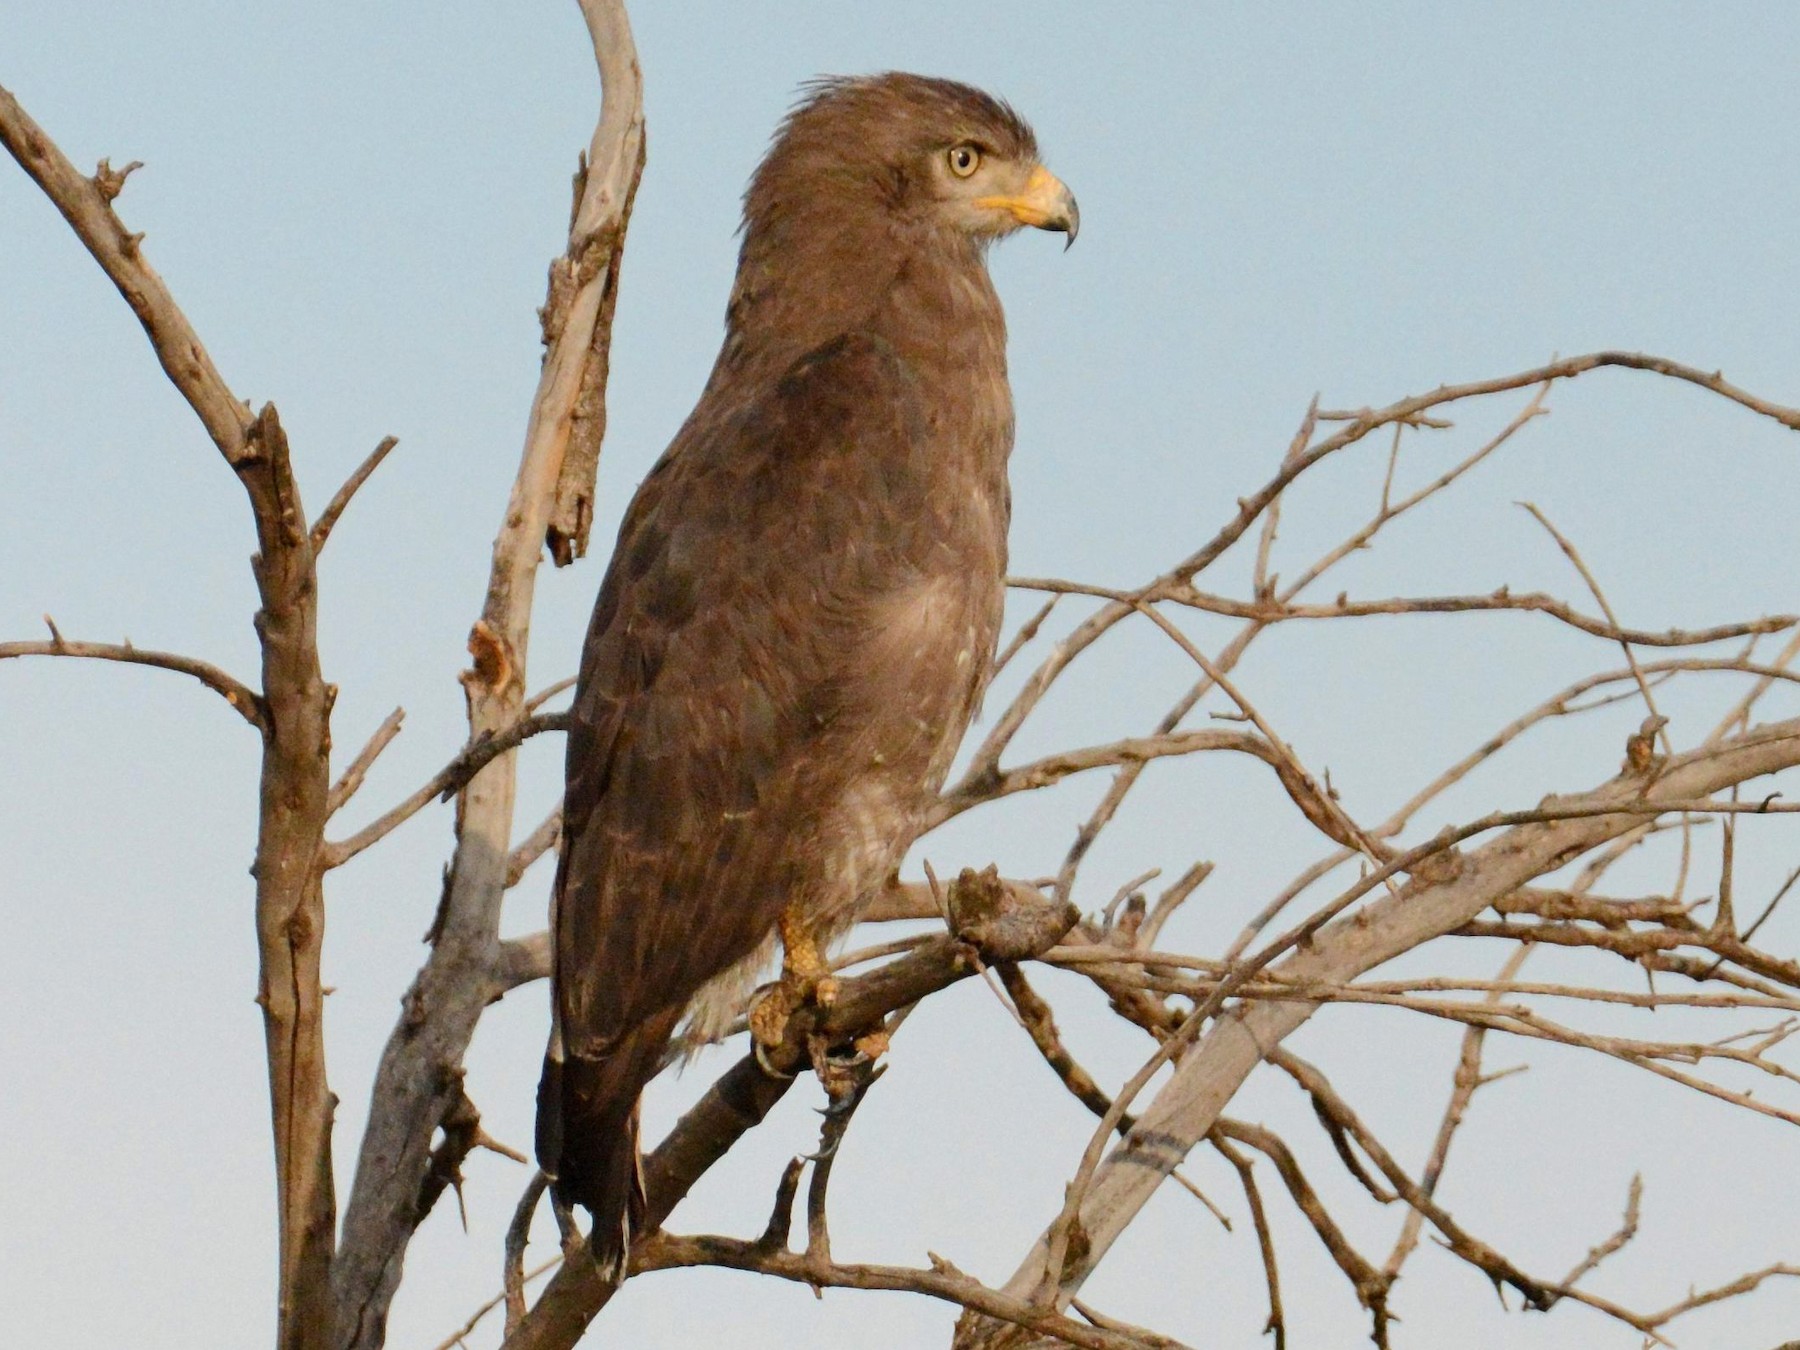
[[538, 74, 1078, 1271]]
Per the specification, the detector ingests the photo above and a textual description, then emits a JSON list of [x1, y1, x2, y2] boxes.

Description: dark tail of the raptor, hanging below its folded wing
[[536, 1008, 680, 1282]]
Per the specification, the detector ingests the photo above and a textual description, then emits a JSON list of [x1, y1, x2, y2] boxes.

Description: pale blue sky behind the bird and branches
[[0, 0, 1800, 1350]]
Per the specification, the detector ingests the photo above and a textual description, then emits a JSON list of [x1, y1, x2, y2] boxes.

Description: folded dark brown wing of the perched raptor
[[554, 335, 950, 1057]]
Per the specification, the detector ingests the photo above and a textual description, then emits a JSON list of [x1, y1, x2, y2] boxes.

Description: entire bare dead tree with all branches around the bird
[[21, 0, 1800, 1350]]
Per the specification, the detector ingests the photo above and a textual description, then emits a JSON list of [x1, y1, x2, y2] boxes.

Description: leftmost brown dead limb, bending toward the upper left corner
[[0, 76, 337, 1350]]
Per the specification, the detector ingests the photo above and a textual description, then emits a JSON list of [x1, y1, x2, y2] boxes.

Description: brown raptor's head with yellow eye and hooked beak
[[743, 74, 1082, 253]]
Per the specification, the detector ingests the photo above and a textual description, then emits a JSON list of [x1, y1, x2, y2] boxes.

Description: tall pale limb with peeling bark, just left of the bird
[[331, 0, 644, 1350]]
